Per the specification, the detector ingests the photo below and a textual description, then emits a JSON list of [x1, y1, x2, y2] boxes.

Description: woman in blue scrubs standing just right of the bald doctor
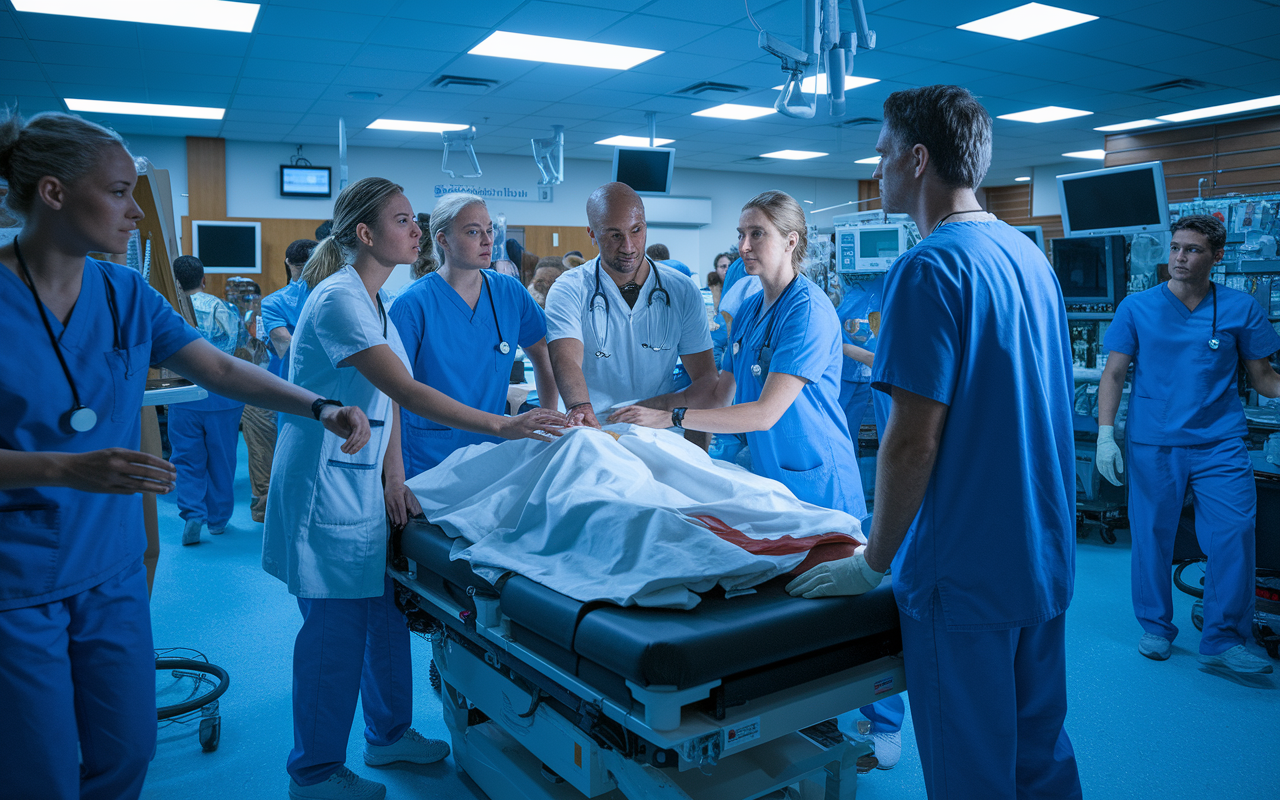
[[609, 192, 905, 769]]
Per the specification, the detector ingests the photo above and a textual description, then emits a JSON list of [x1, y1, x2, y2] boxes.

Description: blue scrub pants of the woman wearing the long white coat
[[288, 577, 413, 786]]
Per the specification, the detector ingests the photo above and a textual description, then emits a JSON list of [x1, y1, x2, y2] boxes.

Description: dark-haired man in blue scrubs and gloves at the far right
[[1097, 215, 1280, 673]]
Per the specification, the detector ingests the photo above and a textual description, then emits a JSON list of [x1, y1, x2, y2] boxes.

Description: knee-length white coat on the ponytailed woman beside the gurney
[[262, 265, 410, 599]]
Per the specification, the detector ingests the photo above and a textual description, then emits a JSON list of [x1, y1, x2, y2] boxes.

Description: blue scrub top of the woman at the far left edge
[[0, 259, 200, 611]]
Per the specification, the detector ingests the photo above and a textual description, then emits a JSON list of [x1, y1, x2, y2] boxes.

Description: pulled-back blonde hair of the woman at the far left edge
[[0, 110, 132, 219]]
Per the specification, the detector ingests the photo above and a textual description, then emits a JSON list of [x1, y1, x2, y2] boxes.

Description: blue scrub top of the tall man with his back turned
[[872, 220, 1075, 631]]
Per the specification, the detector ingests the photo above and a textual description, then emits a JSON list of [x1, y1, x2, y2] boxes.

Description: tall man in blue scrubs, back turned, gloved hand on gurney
[[792, 86, 1080, 800]]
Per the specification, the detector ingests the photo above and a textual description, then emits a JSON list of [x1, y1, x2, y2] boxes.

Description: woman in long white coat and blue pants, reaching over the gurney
[[262, 178, 564, 799]]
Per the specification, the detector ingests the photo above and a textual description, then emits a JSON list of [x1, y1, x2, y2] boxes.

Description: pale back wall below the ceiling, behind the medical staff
[[131, 137, 858, 283]]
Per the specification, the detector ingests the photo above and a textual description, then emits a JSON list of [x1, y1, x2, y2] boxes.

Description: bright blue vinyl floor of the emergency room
[[142, 442, 1280, 800]]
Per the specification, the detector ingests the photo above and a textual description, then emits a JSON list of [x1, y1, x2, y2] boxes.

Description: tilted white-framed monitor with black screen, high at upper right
[[1057, 161, 1169, 237]]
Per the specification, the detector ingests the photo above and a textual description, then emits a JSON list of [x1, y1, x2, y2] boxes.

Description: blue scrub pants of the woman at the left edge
[[0, 559, 156, 800]]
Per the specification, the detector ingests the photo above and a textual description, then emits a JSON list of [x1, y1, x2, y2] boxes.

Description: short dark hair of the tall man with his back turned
[[884, 86, 991, 189]]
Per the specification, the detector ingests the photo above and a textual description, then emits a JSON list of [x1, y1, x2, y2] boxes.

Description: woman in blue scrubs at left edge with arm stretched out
[[0, 113, 369, 800]]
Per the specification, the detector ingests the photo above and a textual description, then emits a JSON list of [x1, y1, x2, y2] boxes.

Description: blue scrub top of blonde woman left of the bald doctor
[[389, 270, 547, 477]]
